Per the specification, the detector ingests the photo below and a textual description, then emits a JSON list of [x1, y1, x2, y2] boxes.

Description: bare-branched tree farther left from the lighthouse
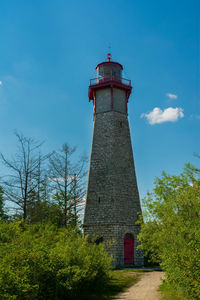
[[0, 132, 49, 220]]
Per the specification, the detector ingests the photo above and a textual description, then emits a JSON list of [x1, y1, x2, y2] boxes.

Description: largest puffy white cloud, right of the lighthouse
[[141, 107, 184, 125]]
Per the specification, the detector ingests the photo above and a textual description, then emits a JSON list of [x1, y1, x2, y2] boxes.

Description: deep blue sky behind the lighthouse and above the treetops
[[0, 0, 200, 197]]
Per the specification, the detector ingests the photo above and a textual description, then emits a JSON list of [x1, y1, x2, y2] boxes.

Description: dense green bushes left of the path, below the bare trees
[[0, 221, 112, 300]]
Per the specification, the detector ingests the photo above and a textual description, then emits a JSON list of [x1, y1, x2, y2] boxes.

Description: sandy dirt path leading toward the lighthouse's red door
[[116, 271, 164, 300]]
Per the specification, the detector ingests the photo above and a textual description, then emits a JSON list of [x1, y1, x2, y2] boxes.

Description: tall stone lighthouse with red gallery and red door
[[83, 52, 143, 266]]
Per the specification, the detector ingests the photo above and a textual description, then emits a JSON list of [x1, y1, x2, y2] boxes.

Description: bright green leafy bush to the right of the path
[[139, 164, 200, 299]]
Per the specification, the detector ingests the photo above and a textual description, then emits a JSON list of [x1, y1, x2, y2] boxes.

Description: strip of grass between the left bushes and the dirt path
[[81, 269, 142, 300]]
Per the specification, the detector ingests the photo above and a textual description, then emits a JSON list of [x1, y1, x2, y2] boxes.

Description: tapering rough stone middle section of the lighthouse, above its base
[[84, 111, 141, 224]]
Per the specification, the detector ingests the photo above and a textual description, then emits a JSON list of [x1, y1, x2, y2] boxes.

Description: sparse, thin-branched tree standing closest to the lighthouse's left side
[[49, 144, 87, 226]]
